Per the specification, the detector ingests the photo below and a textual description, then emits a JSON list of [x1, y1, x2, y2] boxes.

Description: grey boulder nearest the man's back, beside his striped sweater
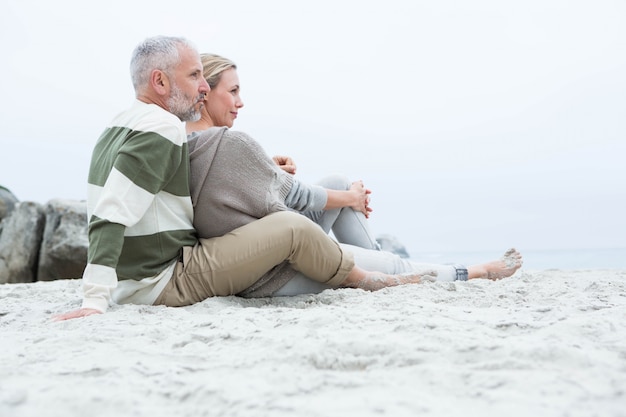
[[37, 199, 89, 281]]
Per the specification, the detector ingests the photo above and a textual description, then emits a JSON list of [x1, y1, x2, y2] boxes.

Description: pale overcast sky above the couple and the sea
[[0, 0, 626, 252]]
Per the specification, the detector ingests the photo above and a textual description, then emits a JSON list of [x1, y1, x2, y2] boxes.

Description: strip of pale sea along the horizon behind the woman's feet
[[409, 248, 626, 271]]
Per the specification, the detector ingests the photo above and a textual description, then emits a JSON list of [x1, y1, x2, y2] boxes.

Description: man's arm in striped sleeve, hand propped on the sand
[[53, 128, 171, 320]]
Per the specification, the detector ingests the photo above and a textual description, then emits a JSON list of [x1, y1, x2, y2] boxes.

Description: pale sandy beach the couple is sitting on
[[0, 270, 626, 417]]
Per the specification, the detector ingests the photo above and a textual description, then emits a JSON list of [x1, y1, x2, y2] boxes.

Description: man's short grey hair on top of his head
[[130, 36, 195, 91]]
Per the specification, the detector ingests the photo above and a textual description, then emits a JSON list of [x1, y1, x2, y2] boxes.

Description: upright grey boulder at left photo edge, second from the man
[[0, 202, 45, 284]]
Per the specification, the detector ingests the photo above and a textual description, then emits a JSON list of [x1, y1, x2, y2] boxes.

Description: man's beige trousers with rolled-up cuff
[[155, 211, 354, 307]]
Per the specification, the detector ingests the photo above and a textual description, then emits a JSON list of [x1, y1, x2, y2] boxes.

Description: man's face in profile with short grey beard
[[167, 48, 210, 122]]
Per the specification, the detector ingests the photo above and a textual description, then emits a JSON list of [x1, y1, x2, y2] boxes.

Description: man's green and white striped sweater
[[83, 100, 197, 312]]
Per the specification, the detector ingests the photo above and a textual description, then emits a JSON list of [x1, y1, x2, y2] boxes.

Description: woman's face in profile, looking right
[[206, 68, 243, 128]]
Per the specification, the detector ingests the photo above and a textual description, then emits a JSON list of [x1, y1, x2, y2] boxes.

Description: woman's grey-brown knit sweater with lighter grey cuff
[[188, 127, 327, 297]]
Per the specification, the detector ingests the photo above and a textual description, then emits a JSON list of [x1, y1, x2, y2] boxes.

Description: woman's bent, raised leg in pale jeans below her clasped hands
[[302, 175, 380, 250]]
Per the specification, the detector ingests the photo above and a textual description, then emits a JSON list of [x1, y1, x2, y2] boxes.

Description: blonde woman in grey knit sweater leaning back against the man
[[187, 54, 521, 297]]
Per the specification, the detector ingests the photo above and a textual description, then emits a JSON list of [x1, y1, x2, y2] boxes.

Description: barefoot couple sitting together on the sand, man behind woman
[[57, 36, 522, 320]]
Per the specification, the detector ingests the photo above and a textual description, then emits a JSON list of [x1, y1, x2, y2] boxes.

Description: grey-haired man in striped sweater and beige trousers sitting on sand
[[56, 36, 434, 320]]
